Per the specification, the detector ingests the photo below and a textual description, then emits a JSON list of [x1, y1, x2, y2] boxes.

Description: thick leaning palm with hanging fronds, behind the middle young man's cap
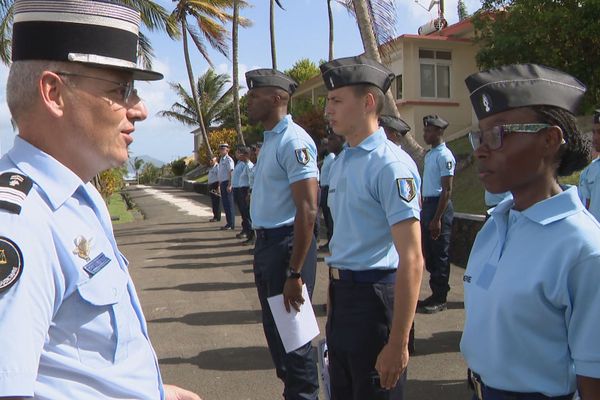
[[346, 0, 425, 165]]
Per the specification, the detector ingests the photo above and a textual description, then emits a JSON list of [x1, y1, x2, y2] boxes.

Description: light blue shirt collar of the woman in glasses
[[492, 186, 584, 225]]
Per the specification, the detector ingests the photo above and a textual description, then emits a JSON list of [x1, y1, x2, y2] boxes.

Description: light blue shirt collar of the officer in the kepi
[[8, 136, 85, 210]]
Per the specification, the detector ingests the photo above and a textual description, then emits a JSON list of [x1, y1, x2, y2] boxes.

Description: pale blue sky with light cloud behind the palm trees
[[0, 0, 481, 162]]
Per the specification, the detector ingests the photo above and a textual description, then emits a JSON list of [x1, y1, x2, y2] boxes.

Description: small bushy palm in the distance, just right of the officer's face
[[158, 69, 234, 131]]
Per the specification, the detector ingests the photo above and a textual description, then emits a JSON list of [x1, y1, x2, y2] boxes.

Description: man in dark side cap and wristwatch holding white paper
[[246, 69, 319, 400]]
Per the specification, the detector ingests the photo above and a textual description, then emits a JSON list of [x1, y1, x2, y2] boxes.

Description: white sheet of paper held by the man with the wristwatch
[[267, 285, 319, 353]]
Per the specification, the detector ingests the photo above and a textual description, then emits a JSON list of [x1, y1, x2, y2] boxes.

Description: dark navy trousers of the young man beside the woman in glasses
[[326, 280, 406, 400]]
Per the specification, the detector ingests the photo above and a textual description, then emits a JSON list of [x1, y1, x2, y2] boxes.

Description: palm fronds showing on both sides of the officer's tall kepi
[[0, 0, 179, 69]]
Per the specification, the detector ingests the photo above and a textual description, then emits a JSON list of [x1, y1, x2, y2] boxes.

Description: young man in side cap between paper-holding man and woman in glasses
[[320, 56, 423, 400]]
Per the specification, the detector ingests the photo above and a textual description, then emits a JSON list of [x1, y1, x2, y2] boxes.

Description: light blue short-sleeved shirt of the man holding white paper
[[250, 115, 318, 229]]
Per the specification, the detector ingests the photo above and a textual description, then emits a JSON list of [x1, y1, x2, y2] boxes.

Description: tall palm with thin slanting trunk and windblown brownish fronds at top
[[171, 0, 248, 161]]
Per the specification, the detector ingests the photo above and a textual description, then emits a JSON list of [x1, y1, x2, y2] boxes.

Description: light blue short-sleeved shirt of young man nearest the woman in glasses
[[326, 128, 421, 271]]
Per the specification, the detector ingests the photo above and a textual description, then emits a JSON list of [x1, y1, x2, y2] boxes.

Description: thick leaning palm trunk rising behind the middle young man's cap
[[352, 0, 425, 167]]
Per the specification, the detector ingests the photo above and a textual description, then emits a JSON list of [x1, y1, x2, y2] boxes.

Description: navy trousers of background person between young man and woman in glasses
[[421, 201, 454, 302]]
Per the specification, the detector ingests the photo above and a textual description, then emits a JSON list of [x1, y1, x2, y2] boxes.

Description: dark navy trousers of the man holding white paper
[[254, 227, 319, 400]]
